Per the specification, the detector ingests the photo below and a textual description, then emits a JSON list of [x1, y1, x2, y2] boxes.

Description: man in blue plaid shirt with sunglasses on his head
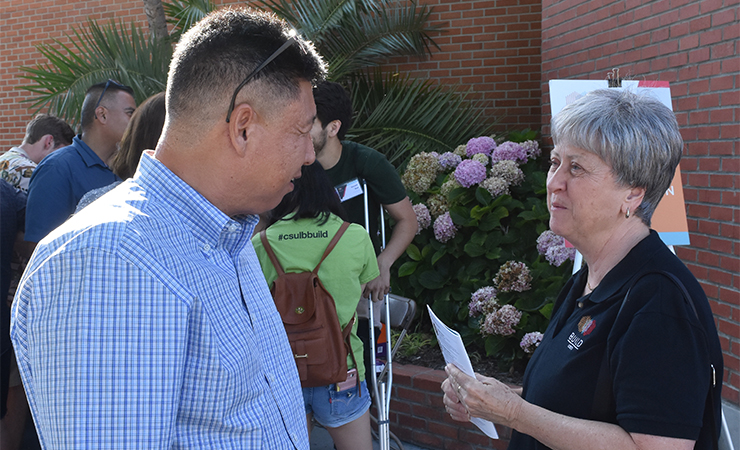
[[11, 9, 325, 449]]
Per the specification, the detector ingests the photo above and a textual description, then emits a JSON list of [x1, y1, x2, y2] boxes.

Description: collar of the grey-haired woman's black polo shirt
[[576, 230, 662, 303]]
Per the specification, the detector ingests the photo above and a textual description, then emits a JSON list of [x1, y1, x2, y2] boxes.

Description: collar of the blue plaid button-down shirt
[[133, 150, 259, 252]]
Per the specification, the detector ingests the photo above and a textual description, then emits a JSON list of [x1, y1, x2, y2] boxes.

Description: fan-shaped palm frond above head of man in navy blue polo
[[20, 20, 172, 125]]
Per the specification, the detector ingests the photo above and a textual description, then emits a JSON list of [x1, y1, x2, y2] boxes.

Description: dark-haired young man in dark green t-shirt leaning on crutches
[[311, 81, 418, 392]]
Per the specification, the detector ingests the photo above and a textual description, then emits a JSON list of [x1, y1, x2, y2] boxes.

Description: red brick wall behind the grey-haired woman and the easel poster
[[542, 0, 740, 404]]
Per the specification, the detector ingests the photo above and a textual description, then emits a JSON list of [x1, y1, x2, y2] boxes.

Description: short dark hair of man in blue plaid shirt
[[167, 8, 326, 118]]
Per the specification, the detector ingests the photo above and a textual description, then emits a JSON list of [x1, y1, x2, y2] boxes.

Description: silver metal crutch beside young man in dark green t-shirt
[[362, 180, 393, 450]]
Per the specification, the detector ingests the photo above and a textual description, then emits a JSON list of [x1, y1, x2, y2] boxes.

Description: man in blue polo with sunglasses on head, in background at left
[[25, 80, 136, 242]]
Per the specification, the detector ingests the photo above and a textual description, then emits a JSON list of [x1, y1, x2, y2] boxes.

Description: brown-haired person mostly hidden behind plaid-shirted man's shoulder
[[75, 92, 165, 213]]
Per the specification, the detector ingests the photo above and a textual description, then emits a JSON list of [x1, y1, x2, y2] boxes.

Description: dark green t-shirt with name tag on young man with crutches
[[326, 141, 406, 247]]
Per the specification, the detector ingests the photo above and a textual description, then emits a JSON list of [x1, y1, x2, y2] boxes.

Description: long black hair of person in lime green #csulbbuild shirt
[[269, 161, 347, 225]]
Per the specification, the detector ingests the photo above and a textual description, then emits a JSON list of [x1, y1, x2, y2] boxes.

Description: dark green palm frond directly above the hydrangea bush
[[349, 70, 493, 165]]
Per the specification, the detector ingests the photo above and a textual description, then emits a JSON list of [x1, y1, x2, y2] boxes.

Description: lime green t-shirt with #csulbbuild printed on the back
[[252, 215, 380, 380]]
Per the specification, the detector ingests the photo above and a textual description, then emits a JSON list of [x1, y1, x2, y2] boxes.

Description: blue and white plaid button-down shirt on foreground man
[[11, 154, 308, 449]]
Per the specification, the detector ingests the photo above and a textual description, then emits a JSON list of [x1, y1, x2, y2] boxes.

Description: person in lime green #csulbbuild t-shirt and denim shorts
[[252, 162, 379, 450]]
